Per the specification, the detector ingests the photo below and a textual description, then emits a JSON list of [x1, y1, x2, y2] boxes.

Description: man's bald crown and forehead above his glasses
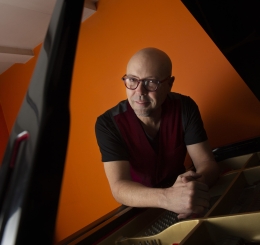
[[127, 48, 172, 79]]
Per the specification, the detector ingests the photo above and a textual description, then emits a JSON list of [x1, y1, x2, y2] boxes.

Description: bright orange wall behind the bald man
[[0, 0, 260, 241]]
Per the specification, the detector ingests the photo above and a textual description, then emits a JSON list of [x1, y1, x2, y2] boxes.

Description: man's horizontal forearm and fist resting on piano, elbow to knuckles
[[108, 173, 209, 217]]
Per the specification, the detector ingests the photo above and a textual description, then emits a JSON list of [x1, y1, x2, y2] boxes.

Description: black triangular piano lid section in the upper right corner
[[182, 0, 260, 100]]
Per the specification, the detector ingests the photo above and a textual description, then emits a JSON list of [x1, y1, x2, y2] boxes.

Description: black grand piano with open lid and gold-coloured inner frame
[[0, 0, 260, 245]]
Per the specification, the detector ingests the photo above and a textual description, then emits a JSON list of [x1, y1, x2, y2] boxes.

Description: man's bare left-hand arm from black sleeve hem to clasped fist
[[104, 161, 209, 214]]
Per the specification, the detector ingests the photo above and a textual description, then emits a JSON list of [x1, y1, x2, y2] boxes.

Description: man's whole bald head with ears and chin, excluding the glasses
[[126, 48, 174, 117]]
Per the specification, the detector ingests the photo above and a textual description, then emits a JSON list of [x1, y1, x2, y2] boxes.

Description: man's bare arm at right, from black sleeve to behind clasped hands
[[187, 141, 219, 187]]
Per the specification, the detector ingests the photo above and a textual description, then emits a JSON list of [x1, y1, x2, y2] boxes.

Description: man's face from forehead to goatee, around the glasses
[[126, 57, 171, 117]]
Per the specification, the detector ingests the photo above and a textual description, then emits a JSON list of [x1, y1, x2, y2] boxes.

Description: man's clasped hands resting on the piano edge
[[165, 171, 210, 219]]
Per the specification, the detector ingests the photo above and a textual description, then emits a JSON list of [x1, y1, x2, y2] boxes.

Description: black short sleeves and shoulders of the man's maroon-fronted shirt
[[95, 92, 207, 162]]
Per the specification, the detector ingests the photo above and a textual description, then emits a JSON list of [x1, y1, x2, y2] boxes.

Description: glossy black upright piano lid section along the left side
[[0, 0, 84, 245]]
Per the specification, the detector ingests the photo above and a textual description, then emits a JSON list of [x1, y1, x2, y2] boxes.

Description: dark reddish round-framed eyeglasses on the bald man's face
[[122, 75, 170, 92]]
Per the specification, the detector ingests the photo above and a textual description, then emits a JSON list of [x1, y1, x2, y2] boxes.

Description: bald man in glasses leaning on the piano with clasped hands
[[96, 48, 219, 218]]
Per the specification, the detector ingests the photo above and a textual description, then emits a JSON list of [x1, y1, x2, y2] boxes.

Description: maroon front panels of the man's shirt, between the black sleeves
[[114, 98, 186, 187]]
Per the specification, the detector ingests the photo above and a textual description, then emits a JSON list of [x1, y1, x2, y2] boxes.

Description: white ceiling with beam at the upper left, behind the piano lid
[[0, 0, 98, 74]]
